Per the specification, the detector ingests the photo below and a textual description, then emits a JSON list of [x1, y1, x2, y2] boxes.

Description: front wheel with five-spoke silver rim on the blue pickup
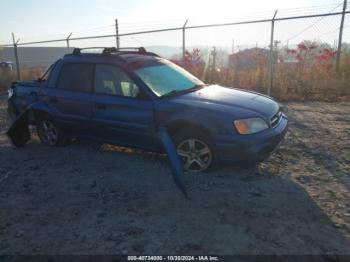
[[173, 129, 216, 173]]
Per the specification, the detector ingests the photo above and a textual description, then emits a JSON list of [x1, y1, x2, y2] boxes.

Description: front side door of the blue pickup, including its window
[[92, 64, 159, 149]]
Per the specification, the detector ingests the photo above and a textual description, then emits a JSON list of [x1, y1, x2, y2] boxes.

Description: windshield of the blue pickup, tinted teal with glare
[[135, 59, 204, 96]]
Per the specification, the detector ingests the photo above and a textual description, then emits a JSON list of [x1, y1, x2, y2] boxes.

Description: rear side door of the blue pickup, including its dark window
[[46, 63, 94, 136]]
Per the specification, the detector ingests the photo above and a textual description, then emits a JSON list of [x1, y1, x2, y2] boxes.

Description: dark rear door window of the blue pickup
[[57, 64, 94, 92]]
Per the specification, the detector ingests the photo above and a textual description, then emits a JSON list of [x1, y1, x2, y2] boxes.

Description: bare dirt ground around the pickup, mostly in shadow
[[0, 97, 350, 255]]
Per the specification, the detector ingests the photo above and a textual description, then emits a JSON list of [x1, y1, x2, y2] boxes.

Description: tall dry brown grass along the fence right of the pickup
[[186, 49, 350, 102]]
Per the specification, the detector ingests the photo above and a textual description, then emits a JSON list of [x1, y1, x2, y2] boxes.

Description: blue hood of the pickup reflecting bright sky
[[170, 85, 279, 118]]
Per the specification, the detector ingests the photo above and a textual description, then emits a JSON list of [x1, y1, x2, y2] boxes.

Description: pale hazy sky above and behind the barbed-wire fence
[[0, 0, 350, 48]]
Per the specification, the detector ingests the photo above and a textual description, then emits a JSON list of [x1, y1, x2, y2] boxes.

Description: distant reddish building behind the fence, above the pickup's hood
[[229, 48, 269, 70]]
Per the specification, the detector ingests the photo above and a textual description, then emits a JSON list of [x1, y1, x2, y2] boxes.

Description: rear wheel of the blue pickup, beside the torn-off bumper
[[37, 119, 66, 147]]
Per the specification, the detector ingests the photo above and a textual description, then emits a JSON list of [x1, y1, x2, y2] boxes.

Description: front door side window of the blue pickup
[[95, 65, 139, 97]]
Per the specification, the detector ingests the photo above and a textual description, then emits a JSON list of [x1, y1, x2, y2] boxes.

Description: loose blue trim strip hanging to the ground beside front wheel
[[159, 127, 189, 199]]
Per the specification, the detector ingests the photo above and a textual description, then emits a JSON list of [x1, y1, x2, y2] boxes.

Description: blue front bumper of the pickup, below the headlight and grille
[[215, 115, 288, 162]]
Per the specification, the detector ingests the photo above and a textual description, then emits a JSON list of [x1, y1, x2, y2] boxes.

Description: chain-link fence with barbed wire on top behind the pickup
[[0, 2, 350, 100]]
